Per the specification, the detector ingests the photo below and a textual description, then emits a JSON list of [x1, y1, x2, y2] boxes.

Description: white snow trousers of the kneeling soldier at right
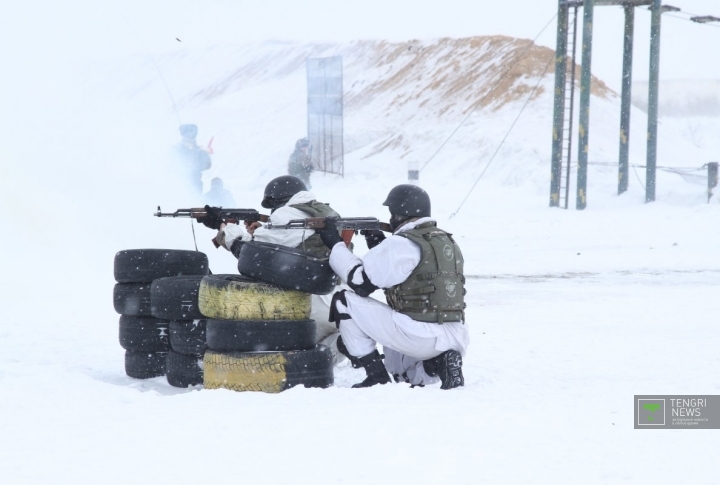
[[335, 291, 470, 385]]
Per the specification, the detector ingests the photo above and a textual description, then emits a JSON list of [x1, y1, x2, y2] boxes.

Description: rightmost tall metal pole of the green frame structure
[[645, 0, 662, 202]]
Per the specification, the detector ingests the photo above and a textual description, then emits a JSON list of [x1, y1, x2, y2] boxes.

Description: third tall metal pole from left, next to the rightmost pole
[[618, 5, 635, 195]]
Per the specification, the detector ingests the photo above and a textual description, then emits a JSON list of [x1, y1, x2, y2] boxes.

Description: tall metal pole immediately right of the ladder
[[575, 0, 592, 210]]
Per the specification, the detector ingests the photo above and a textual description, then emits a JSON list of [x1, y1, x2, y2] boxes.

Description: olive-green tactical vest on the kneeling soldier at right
[[385, 222, 466, 324]]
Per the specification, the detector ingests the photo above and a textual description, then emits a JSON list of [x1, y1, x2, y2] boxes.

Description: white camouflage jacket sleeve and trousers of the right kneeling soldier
[[330, 217, 470, 385]]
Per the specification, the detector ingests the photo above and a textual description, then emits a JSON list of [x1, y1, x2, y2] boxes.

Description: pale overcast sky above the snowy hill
[[0, 0, 720, 93]]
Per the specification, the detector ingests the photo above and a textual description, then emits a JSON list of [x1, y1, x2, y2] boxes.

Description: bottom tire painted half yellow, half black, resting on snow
[[203, 346, 333, 393]]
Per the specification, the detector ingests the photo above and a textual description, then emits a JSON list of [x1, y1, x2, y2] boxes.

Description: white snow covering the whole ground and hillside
[[0, 1, 720, 485]]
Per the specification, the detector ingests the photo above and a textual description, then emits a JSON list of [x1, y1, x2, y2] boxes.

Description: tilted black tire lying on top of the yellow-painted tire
[[238, 241, 337, 295]]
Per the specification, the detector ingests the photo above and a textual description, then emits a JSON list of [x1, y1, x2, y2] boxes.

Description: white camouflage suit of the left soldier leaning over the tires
[[216, 190, 345, 364]]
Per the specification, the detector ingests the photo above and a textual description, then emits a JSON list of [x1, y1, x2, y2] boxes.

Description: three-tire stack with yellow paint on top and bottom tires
[[198, 275, 333, 393]]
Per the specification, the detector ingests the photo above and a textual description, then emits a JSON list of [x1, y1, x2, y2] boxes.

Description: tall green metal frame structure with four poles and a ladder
[[550, 0, 664, 210]]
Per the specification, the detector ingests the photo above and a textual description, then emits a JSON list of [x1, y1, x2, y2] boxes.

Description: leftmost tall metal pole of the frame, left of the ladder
[[550, 0, 568, 207]]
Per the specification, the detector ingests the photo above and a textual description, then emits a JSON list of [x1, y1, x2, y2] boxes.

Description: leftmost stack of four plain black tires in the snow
[[113, 249, 209, 379]]
